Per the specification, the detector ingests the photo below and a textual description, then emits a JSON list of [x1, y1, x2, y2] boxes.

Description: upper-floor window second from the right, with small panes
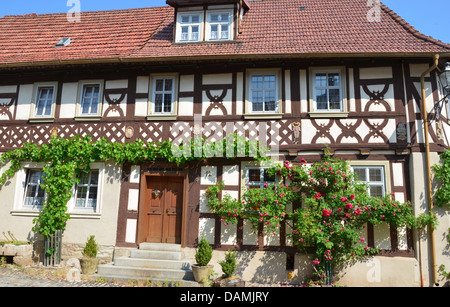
[[249, 73, 278, 113]]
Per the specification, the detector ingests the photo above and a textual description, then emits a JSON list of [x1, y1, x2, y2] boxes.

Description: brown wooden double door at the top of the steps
[[138, 176, 184, 244]]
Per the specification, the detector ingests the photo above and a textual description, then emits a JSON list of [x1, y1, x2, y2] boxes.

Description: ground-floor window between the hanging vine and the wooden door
[[75, 170, 99, 212]]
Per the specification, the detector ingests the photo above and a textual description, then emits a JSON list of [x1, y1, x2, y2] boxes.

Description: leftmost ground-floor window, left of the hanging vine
[[23, 169, 45, 209]]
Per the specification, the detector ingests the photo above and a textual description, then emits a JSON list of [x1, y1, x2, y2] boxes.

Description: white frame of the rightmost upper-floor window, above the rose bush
[[309, 67, 348, 118]]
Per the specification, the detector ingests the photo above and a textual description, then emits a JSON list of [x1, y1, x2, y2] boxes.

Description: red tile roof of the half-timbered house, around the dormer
[[0, 0, 450, 66]]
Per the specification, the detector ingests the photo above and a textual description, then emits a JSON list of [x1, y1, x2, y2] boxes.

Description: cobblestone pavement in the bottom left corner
[[0, 266, 124, 288]]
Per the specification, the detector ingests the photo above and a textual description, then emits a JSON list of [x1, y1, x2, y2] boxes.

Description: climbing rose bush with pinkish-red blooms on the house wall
[[207, 155, 416, 278]]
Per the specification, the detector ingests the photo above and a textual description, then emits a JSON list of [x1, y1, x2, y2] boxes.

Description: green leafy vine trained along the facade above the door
[[0, 135, 267, 238]]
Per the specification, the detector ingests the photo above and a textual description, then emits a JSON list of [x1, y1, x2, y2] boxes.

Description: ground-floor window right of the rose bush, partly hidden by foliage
[[352, 166, 386, 197]]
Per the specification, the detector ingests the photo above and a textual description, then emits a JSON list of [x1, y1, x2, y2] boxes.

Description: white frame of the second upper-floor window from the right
[[248, 70, 280, 114]]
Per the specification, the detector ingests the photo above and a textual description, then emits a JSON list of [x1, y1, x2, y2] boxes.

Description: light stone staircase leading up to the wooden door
[[97, 243, 198, 287]]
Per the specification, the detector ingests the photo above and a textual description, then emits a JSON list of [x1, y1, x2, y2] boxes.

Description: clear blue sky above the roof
[[0, 0, 450, 44]]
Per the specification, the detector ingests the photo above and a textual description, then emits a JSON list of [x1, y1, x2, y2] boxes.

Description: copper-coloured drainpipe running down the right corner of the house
[[419, 54, 439, 285]]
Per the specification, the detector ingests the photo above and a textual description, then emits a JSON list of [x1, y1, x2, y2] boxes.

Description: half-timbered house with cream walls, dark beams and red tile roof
[[0, 0, 450, 286]]
